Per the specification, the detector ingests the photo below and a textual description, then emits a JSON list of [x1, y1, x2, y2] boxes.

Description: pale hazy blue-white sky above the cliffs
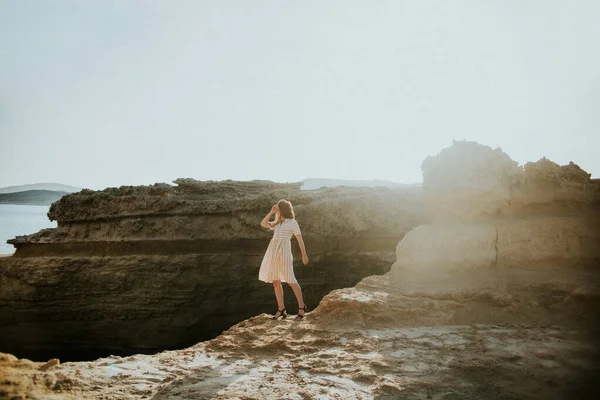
[[0, 0, 600, 189]]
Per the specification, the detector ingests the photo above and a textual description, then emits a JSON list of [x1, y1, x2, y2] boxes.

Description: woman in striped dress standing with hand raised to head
[[258, 200, 308, 319]]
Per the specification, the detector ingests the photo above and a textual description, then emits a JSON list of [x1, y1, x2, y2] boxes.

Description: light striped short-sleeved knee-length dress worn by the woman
[[258, 219, 300, 283]]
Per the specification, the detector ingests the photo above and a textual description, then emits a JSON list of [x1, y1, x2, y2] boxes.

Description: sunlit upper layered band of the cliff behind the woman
[[9, 179, 422, 250]]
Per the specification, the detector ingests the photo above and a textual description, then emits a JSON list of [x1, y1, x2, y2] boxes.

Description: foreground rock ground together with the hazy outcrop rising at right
[[0, 142, 600, 400]]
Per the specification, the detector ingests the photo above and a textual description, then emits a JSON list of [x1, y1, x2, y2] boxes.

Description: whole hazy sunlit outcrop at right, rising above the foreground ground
[[393, 141, 600, 276]]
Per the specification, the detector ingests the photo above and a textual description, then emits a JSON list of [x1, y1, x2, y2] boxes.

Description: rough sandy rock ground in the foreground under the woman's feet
[[0, 271, 600, 400]]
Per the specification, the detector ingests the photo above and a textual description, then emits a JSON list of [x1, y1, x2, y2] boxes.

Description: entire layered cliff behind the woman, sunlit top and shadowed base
[[0, 179, 422, 360]]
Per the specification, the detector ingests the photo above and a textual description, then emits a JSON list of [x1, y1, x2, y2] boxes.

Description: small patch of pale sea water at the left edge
[[0, 204, 56, 254]]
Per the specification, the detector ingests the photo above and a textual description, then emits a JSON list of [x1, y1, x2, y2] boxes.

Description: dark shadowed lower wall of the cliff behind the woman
[[0, 249, 394, 361]]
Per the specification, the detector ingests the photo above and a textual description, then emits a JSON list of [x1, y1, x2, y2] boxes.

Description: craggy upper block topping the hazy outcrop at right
[[421, 141, 600, 221]]
